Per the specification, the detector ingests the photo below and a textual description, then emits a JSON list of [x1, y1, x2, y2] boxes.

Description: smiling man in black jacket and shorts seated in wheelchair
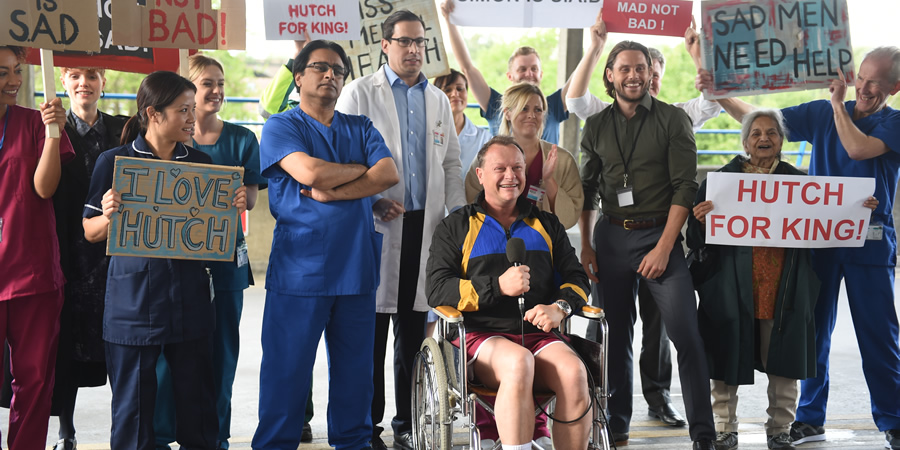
[[426, 136, 591, 450]]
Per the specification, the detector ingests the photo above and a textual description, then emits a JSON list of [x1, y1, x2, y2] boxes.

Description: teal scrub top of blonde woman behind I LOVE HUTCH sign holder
[[188, 122, 266, 291]]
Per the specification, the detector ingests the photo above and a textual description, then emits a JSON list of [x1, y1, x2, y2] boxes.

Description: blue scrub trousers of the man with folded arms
[[253, 291, 375, 450]]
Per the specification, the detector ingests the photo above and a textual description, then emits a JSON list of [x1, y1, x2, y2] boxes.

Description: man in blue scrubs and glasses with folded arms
[[253, 41, 398, 450]]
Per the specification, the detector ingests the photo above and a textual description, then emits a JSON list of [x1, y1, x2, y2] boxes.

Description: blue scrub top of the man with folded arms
[[260, 108, 391, 296]]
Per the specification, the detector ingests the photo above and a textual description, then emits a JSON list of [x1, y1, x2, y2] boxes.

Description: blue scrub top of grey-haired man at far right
[[781, 100, 900, 266]]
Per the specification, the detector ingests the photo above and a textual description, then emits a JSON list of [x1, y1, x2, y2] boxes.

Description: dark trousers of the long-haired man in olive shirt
[[594, 216, 716, 440]]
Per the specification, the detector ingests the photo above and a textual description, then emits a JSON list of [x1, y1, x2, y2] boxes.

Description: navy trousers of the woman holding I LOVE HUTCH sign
[[106, 336, 219, 450]]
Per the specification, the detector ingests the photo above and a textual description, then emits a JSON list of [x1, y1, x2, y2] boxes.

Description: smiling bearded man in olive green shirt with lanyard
[[579, 41, 716, 450]]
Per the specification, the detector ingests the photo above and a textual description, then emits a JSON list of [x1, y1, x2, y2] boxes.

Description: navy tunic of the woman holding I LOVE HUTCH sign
[[83, 136, 216, 345]]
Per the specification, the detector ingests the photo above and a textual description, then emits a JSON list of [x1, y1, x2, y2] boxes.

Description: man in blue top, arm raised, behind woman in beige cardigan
[[441, 0, 569, 144]]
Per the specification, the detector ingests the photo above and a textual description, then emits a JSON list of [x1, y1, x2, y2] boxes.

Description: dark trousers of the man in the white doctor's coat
[[372, 211, 428, 436]]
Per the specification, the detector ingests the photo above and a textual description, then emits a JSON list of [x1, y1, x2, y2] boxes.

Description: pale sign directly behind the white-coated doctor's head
[[338, 0, 448, 82]]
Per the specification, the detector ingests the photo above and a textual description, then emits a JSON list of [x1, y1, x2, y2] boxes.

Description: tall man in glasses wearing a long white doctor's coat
[[336, 10, 465, 450]]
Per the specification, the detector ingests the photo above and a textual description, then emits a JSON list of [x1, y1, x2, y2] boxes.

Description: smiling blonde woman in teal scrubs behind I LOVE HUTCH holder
[[153, 53, 266, 449]]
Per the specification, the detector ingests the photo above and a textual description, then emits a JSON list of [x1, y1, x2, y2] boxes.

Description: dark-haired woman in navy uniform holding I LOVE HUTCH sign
[[84, 72, 246, 450]]
